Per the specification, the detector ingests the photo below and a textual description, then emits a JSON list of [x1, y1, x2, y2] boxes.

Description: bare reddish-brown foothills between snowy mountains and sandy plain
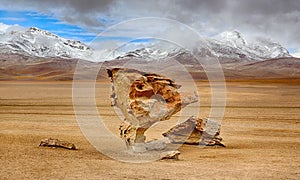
[[0, 54, 300, 81]]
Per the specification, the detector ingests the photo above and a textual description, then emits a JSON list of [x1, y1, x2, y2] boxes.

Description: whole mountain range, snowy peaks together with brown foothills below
[[0, 27, 300, 80]]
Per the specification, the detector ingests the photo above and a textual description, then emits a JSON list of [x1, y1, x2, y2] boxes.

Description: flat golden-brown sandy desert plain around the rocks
[[0, 80, 300, 179]]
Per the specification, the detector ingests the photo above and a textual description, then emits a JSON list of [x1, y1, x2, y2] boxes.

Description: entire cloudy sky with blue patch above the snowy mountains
[[0, 0, 300, 56]]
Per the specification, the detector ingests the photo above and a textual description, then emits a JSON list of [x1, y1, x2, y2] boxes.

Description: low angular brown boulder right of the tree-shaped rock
[[163, 117, 224, 146]]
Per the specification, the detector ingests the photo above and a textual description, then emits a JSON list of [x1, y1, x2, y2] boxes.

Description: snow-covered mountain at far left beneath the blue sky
[[0, 27, 93, 59]]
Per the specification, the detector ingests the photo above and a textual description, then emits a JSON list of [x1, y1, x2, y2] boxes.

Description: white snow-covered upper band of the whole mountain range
[[0, 27, 291, 61]]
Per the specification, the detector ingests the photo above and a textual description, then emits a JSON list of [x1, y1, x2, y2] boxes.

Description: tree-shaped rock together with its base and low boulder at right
[[107, 68, 224, 159]]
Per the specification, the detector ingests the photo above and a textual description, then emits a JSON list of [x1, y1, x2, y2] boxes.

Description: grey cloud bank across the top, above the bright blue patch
[[0, 0, 300, 47]]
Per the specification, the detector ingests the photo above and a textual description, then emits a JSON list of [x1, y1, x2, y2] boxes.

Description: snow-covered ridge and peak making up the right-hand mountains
[[119, 31, 291, 60]]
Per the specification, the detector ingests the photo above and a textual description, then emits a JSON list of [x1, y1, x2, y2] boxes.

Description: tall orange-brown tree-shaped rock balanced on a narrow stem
[[107, 68, 198, 148]]
